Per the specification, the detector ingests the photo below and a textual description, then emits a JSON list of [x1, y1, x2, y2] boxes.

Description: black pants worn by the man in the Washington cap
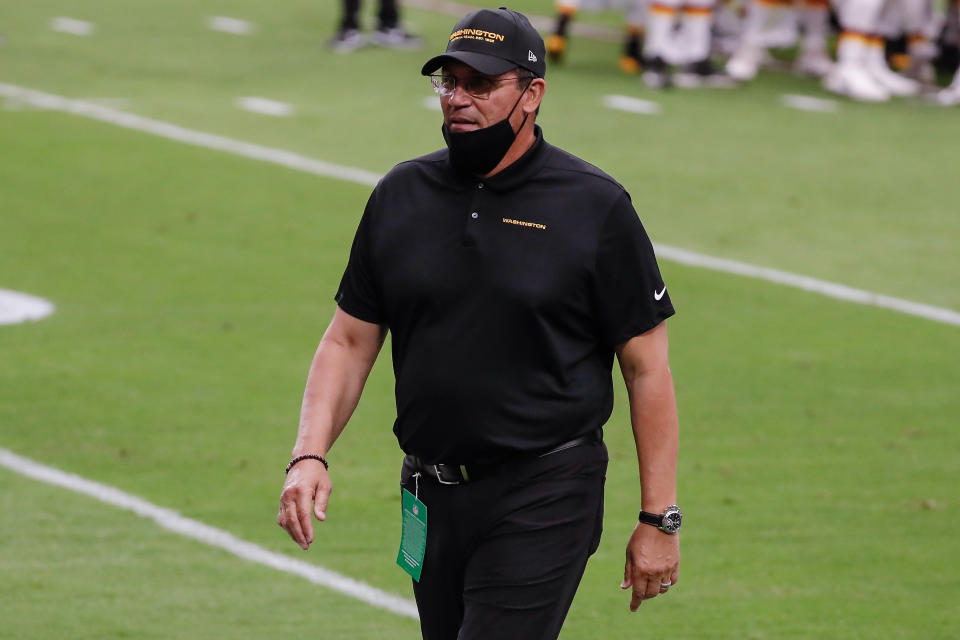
[[401, 442, 607, 640]]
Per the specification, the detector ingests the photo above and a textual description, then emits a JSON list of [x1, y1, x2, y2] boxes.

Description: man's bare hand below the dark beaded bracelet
[[277, 459, 333, 550]]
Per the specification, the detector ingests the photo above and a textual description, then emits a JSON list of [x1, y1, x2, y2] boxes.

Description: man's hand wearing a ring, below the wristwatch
[[620, 522, 680, 611]]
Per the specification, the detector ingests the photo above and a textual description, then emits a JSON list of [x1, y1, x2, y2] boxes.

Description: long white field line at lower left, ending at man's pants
[[0, 447, 419, 620]]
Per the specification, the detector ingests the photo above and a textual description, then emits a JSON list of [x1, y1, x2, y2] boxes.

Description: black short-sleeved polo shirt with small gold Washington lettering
[[336, 127, 674, 464]]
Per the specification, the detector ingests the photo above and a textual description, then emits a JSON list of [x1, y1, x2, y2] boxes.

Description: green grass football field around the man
[[0, 0, 960, 640]]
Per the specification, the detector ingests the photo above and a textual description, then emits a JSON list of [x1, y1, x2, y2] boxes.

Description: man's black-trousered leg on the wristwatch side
[[457, 443, 607, 640]]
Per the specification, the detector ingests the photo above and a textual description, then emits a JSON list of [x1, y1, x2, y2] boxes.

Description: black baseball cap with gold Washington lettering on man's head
[[420, 7, 547, 78]]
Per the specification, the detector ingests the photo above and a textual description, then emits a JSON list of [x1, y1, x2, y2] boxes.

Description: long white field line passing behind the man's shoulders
[[0, 83, 960, 326]]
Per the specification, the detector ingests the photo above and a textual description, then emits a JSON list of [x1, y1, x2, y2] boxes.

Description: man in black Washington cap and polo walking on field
[[278, 9, 681, 640]]
